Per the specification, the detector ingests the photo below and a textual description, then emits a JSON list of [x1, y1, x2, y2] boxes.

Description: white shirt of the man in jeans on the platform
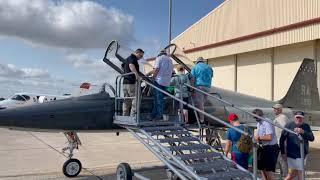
[[154, 55, 173, 86]]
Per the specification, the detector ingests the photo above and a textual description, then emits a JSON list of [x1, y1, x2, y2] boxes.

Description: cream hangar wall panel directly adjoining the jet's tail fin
[[274, 41, 315, 100]]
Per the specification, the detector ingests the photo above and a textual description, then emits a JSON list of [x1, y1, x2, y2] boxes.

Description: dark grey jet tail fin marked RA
[[279, 58, 320, 110]]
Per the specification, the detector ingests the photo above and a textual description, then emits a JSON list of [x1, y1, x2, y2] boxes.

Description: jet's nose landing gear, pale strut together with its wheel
[[62, 131, 82, 177]]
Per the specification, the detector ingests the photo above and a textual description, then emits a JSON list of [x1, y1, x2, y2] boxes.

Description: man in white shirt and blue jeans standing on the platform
[[148, 50, 173, 120]]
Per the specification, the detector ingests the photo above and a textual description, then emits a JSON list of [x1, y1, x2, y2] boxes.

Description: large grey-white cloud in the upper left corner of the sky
[[0, 0, 133, 48]]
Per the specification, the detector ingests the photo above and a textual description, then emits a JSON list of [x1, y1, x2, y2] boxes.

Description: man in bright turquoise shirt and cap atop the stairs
[[191, 57, 213, 123]]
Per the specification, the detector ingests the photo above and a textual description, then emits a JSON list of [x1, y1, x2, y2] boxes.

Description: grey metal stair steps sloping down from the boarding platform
[[127, 125, 253, 180]]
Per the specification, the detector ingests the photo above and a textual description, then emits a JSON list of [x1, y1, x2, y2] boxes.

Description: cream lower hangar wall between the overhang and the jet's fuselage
[[208, 41, 320, 100]]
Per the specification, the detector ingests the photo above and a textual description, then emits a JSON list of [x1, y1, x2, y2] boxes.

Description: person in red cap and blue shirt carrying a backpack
[[224, 113, 250, 169]]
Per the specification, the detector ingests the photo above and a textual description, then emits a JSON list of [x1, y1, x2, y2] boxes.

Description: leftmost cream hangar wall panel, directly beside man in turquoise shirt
[[208, 56, 235, 91]]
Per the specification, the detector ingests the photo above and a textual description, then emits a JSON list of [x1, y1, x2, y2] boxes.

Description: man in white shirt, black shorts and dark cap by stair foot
[[252, 109, 279, 180]]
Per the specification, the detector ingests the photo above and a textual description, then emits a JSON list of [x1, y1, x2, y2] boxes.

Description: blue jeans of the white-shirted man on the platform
[[152, 83, 166, 118]]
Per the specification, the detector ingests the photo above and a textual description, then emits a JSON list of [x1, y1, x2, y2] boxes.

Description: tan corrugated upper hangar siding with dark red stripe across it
[[174, 0, 320, 58]]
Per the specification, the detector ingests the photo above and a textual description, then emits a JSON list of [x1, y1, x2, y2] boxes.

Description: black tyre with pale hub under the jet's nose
[[62, 159, 82, 177]]
